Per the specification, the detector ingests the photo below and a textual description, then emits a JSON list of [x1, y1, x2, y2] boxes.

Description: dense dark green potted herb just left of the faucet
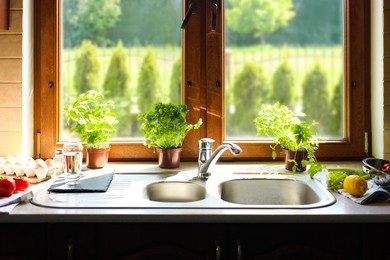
[[138, 102, 202, 169]]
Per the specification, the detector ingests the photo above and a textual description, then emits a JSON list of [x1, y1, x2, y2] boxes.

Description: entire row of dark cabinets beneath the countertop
[[0, 223, 380, 260]]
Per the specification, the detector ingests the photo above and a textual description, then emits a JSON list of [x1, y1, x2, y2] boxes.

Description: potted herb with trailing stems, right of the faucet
[[255, 102, 322, 177]]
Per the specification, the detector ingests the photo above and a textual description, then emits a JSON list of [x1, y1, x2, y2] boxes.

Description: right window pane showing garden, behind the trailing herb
[[225, 0, 344, 140]]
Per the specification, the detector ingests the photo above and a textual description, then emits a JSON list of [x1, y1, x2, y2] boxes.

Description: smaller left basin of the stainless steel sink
[[146, 181, 206, 202]]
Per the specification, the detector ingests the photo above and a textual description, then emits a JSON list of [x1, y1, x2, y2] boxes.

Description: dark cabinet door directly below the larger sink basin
[[231, 223, 361, 260]]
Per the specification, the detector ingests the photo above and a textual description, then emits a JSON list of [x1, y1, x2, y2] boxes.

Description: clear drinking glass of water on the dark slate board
[[63, 141, 83, 185]]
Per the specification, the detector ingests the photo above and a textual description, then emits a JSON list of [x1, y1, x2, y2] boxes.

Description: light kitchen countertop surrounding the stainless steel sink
[[0, 162, 390, 223]]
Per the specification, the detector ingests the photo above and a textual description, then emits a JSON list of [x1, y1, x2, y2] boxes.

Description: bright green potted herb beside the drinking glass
[[64, 90, 119, 169]]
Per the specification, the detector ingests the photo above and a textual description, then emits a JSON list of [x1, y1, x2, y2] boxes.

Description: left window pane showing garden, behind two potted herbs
[[60, 0, 182, 141]]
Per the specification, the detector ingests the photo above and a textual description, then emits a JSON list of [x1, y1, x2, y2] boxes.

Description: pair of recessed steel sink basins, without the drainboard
[[146, 178, 327, 207]]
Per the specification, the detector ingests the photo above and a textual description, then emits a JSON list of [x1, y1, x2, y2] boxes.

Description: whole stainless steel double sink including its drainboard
[[32, 167, 335, 209]]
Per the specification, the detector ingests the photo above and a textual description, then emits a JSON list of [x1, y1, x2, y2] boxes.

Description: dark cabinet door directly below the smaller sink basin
[[97, 223, 227, 260]]
